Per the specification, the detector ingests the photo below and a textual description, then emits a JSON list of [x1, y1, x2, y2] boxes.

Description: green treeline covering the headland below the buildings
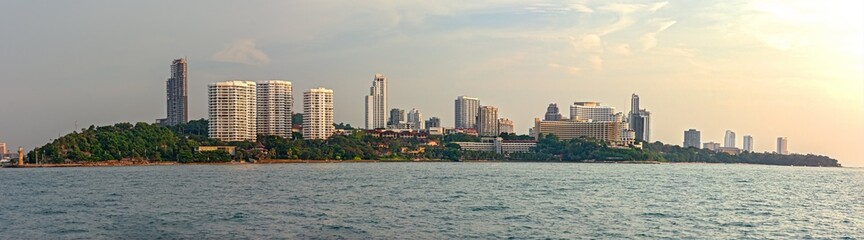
[[27, 120, 839, 166]]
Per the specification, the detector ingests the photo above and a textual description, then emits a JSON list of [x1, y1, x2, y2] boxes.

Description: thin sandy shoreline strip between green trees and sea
[[2, 159, 844, 168]]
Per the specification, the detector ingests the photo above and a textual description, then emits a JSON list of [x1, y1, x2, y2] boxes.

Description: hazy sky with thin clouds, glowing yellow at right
[[0, 0, 864, 167]]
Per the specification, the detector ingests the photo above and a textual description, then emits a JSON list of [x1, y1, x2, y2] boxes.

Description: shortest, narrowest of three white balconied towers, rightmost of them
[[303, 88, 336, 139]]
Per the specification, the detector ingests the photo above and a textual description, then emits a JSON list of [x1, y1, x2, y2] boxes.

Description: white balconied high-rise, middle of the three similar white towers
[[256, 80, 294, 138]]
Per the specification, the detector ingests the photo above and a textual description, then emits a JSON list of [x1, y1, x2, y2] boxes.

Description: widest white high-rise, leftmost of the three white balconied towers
[[208, 81, 257, 142]]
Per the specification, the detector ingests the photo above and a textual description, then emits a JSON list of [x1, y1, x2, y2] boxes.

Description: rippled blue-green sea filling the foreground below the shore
[[0, 162, 864, 239]]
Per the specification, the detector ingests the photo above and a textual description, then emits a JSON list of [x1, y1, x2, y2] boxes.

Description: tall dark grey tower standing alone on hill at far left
[[164, 58, 189, 126]]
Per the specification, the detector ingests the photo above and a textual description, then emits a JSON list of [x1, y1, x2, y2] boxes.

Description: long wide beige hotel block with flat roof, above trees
[[534, 118, 624, 145]]
